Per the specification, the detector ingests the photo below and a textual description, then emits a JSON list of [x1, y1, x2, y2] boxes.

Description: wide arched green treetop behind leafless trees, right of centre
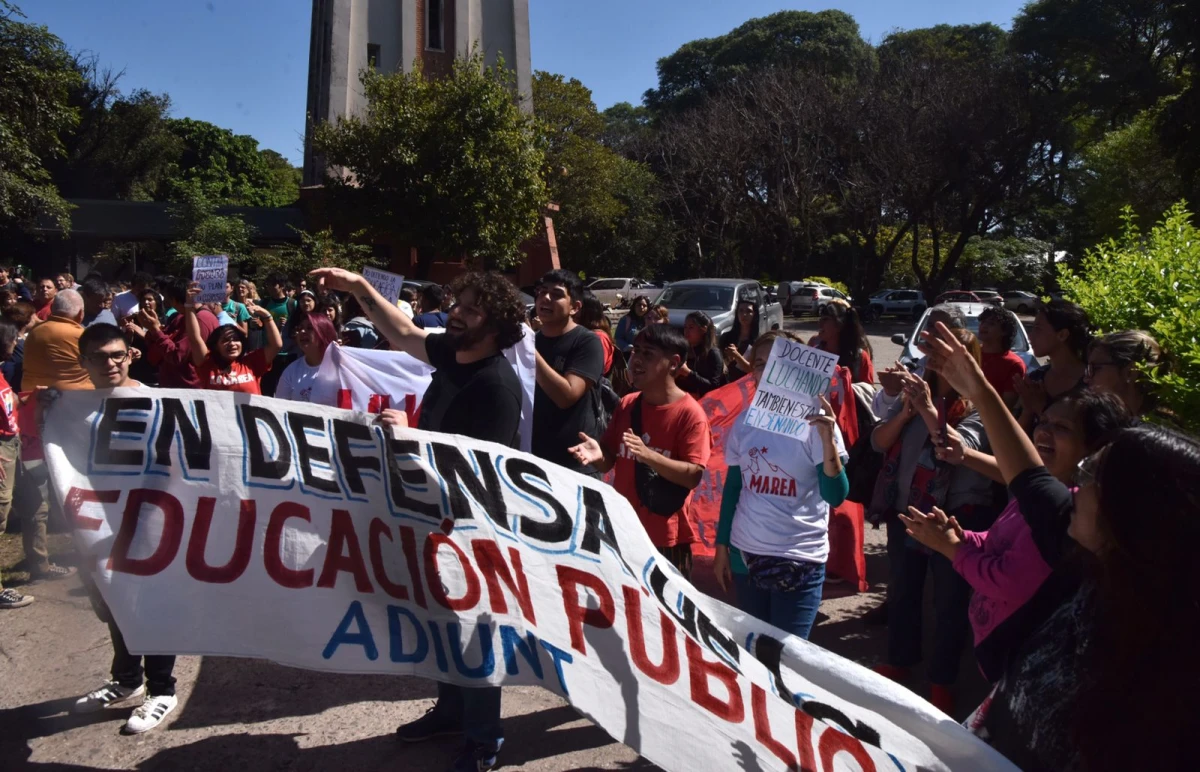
[[644, 11, 872, 113]]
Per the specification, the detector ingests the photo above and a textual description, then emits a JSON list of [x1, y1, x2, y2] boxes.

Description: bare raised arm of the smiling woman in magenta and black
[[922, 322, 1042, 485]]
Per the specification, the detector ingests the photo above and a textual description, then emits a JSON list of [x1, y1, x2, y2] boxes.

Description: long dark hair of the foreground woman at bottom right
[[1072, 425, 1200, 770]]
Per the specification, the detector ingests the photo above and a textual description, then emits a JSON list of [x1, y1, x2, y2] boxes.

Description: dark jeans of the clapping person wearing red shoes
[[888, 517, 971, 687]]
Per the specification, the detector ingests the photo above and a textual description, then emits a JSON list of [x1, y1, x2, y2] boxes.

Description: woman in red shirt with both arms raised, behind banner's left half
[[184, 283, 283, 395]]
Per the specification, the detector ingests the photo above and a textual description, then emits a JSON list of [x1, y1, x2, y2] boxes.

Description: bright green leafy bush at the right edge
[[1058, 202, 1200, 432]]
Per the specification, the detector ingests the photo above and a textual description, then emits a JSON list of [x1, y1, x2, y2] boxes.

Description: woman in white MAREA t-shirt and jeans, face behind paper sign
[[713, 330, 850, 639]]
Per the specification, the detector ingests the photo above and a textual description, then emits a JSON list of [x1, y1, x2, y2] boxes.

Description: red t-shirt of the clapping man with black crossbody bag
[[600, 394, 713, 547]]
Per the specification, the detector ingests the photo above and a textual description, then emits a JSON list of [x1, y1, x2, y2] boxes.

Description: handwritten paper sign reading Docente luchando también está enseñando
[[745, 337, 838, 438]]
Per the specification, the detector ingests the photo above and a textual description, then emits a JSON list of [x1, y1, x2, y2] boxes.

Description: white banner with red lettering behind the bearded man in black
[[311, 327, 538, 451]]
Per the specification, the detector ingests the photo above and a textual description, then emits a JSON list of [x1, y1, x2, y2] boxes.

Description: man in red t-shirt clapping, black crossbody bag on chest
[[570, 324, 713, 579]]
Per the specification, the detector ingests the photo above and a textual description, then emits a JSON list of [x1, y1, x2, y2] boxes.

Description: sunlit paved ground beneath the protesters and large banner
[[0, 319, 983, 772]]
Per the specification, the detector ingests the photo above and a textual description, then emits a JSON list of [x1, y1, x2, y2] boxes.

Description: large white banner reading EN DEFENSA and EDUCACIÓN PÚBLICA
[[44, 389, 1014, 772]]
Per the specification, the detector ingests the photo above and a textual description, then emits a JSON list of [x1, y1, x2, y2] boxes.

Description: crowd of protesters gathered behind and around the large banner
[[0, 261, 1200, 770]]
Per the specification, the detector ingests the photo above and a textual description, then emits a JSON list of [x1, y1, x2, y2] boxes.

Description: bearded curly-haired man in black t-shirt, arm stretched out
[[311, 268, 524, 772]]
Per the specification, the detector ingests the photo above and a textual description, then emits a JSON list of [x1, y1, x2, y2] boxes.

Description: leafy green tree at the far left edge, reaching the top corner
[[0, 0, 79, 231]]
